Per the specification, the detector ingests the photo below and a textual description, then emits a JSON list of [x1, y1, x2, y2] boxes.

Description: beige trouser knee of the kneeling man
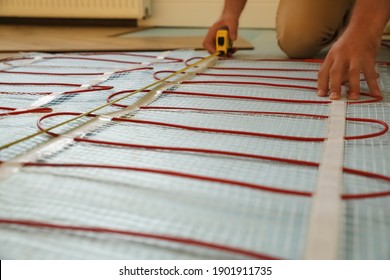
[[276, 0, 355, 58]]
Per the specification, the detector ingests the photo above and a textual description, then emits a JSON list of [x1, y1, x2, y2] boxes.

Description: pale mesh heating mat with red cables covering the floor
[[0, 50, 390, 259]]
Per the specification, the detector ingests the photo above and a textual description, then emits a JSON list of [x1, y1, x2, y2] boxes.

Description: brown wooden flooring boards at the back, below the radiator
[[0, 25, 253, 58]]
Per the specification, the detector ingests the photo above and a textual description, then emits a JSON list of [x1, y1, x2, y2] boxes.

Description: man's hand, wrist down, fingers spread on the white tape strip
[[318, 30, 381, 100]]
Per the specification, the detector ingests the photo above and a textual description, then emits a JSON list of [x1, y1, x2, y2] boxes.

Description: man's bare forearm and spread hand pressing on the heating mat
[[318, 0, 390, 99]]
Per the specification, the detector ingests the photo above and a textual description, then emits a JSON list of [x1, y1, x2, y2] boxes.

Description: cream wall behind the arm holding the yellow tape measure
[[139, 0, 278, 28]]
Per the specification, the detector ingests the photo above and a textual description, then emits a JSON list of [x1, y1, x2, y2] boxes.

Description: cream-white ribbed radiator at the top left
[[0, 0, 151, 19]]
